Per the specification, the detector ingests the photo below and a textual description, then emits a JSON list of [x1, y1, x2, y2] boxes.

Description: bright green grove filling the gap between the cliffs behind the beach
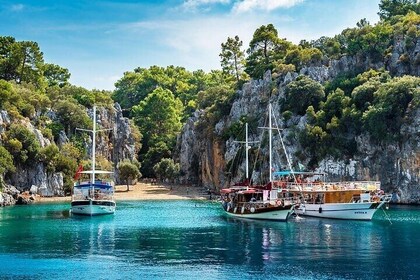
[[113, 63, 235, 177]]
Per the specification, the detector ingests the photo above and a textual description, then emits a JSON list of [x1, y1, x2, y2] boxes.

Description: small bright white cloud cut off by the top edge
[[232, 0, 304, 13]]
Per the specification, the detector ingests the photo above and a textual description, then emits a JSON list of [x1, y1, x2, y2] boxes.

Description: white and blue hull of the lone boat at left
[[71, 200, 116, 216]]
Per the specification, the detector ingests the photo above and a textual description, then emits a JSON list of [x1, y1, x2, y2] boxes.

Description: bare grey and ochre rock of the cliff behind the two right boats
[[178, 39, 420, 204]]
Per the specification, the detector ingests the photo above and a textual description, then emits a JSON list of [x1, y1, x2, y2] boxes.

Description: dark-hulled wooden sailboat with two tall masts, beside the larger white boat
[[220, 104, 294, 221]]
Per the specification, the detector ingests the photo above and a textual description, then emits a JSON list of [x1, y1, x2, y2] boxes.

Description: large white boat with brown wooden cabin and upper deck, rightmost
[[274, 171, 391, 220]]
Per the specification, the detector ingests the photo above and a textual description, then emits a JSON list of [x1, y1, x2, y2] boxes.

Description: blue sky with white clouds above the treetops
[[0, 0, 380, 90]]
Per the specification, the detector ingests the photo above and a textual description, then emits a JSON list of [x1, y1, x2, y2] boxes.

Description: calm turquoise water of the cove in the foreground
[[0, 201, 420, 279]]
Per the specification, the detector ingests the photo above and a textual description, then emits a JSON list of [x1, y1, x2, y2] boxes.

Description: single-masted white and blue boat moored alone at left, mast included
[[70, 106, 116, 216]]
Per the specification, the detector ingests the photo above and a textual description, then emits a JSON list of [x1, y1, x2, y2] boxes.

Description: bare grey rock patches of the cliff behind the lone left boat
[[0, 103, 136, 205]]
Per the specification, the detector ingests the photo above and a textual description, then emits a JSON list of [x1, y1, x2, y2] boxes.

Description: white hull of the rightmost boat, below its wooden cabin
[[295, 202, 385, 220]]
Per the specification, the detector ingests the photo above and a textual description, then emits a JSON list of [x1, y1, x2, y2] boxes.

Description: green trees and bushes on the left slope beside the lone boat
[[0, 36, 124, 193]]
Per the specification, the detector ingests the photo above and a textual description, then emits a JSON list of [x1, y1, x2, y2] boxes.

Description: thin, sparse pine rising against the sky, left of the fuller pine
[[219, 36, 245, 83]]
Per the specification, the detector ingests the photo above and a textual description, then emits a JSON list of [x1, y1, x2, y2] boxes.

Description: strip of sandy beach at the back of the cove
[[36, 182, 207, 202]]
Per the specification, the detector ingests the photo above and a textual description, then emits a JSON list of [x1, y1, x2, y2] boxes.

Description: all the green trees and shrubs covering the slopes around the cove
[[0, 0, 420, 188]]
